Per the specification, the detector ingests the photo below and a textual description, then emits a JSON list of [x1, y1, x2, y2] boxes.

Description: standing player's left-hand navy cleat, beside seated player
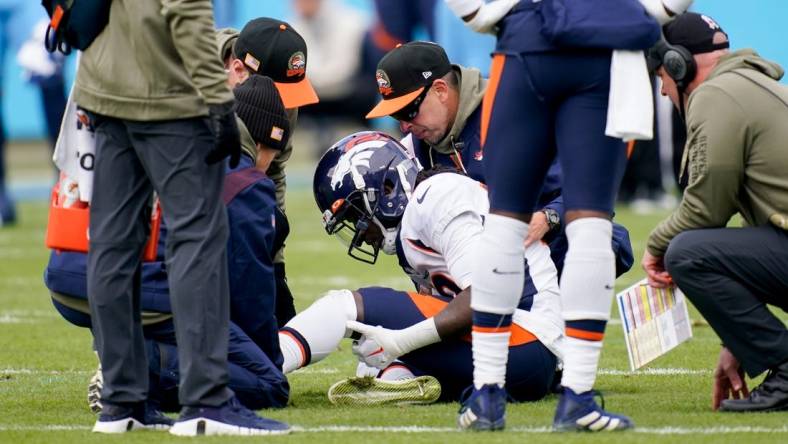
[[457, 384, 507, 431]]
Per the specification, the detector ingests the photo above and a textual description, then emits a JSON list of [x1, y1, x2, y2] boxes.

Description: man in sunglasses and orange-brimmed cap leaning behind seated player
[[367, 41, 633, 274]]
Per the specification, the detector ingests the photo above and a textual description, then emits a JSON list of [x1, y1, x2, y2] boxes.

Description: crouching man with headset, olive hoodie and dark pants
[[642, 13, 788, 412]]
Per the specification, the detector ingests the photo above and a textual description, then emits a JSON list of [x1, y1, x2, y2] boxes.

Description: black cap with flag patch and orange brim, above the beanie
[[233, 17, 318, 108]]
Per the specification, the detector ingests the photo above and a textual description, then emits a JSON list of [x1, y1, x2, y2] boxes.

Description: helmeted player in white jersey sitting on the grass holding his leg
[[279, 132, 562, 404]]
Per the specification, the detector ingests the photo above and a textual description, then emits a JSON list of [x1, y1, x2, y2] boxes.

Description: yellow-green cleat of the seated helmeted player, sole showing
[[328, 376, 441, 406]]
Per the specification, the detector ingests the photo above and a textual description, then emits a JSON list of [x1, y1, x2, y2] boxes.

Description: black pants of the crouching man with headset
[[665, 226, 788, 377]]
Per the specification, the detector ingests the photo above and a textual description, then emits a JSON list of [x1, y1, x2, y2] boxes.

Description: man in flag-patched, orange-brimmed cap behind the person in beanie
[[216, 17, 318, 326]]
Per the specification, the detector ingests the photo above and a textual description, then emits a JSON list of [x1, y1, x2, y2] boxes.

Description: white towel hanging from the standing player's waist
[[605, 49, 654, 142]]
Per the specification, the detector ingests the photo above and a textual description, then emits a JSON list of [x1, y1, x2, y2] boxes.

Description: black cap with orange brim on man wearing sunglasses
[[367, 41, 451, 119]]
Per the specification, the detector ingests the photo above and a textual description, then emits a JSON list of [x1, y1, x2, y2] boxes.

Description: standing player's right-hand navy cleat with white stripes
[[553, 387, 635, 432]]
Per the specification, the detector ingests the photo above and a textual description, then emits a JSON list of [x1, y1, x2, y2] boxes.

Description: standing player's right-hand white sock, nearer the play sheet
[[561, 218, 615, 393]]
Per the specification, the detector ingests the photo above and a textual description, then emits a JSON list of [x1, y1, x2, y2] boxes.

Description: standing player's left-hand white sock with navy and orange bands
[[471, 214, 528, 388]]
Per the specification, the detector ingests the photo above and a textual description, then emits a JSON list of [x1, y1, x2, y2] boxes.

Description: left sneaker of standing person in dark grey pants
[[93, 402, 174, 433]]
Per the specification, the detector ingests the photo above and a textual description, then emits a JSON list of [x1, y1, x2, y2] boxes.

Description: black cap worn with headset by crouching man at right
[[662, 12, 730, 54]]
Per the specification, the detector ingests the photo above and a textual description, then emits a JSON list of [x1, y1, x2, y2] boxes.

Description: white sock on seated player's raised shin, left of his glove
[[279, 290, 357, 374]]
